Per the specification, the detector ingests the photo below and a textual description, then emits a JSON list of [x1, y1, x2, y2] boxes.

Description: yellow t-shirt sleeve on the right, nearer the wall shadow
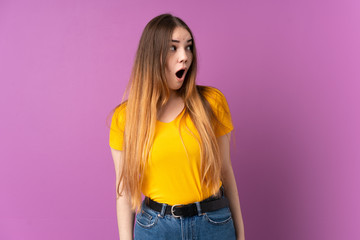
[[205, 88, 234, 137]]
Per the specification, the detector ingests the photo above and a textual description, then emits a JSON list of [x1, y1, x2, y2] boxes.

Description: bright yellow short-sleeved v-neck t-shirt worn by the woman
[[109, 88, 233, 205]]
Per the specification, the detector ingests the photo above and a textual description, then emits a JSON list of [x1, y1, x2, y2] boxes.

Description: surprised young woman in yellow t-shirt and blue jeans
[[110, 14, 244, 240]]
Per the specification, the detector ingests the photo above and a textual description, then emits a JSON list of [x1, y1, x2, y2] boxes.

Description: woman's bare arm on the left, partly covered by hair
[[110, 148, 134, 240]]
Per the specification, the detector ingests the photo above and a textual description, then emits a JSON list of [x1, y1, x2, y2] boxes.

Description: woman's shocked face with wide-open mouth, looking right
[[165, 27, 193, 90]]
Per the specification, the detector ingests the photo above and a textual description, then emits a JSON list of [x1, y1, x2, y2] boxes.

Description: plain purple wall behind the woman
[[0, 0, 360, 240]]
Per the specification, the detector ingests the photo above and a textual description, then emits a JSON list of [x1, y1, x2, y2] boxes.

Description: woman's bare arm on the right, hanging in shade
[[218, 133, 245, 240]]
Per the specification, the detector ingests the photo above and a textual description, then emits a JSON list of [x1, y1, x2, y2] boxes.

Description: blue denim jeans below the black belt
[[134, 196, 236, 240]]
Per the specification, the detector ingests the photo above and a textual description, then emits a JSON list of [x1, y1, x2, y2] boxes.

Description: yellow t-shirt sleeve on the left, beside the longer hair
[[109, 104, 126, 151]]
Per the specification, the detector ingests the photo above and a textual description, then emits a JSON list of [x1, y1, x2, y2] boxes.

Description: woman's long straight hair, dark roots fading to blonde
[[117, 14, 221, 209]]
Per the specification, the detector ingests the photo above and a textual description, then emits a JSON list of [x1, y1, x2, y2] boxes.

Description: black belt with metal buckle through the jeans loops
[[145, 188, 229, 217]]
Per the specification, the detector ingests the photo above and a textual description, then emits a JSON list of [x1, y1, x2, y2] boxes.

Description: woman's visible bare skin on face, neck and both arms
[[111, 27, 245, 240]]
